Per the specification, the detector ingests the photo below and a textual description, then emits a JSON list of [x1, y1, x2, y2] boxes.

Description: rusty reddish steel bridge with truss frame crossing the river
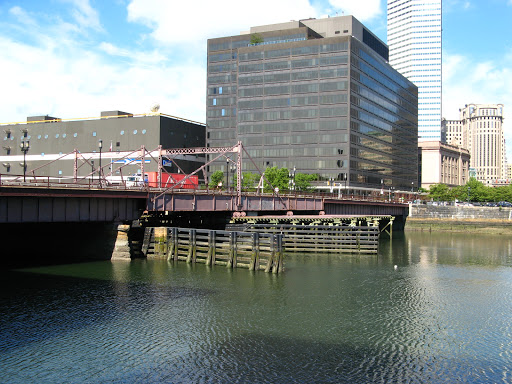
[[0, 142, 409, 223]]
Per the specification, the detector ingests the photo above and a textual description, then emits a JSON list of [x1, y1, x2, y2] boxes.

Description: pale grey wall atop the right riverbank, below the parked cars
[[409, 205, 512, 222]]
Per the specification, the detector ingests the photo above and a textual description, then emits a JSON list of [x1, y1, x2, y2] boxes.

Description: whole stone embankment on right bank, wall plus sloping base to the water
[[405, 204, 512, 235]]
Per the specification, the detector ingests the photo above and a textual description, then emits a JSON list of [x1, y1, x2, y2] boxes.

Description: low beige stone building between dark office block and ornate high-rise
[[418, 141, 470, 189]]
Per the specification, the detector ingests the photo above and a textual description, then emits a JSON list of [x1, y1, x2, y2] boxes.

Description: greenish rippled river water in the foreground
[[0, 233, 512, 383]]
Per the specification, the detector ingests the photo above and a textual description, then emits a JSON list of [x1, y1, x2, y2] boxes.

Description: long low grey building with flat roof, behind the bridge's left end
[[0, 111, 206, 178]]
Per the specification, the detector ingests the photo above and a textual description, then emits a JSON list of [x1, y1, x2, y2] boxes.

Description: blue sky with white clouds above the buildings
[[0, 0, 512, 156]]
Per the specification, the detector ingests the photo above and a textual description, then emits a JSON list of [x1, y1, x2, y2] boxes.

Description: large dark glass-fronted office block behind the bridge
[[206, 16, 418, 190]]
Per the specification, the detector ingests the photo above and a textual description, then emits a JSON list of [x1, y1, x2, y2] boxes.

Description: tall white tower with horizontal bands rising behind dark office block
[[387, 0, 442, 141]]
